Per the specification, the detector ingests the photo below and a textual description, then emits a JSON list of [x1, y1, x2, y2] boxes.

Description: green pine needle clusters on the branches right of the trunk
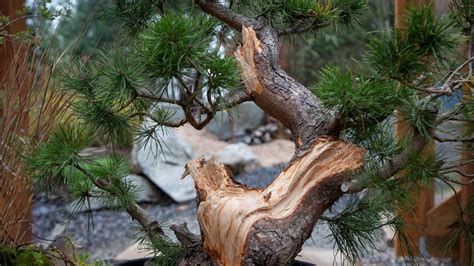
[[313, 3, 472, 263]]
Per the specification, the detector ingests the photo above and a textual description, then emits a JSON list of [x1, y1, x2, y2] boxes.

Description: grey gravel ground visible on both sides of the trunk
[[33, 165, 454, 266]]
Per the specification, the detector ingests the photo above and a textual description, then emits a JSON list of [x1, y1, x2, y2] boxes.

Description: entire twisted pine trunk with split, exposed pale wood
[[181, 27, 365, 265]]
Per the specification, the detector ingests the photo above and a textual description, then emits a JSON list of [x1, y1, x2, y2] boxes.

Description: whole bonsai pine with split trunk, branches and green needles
[[28, 0, 474, 265]]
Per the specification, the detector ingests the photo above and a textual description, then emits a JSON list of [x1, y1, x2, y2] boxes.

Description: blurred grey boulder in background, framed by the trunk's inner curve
[[206, 102, 265, 140]]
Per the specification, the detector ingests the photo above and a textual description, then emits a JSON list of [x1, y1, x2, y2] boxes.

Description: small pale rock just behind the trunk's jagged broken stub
[[216, 143, 259, 175]]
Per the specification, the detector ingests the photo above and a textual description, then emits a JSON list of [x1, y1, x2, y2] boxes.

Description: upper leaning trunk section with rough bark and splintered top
[[236, 27, 338, 151]]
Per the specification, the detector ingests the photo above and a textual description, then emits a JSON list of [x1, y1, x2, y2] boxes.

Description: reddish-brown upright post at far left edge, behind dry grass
[[0, 0, 32, 245]]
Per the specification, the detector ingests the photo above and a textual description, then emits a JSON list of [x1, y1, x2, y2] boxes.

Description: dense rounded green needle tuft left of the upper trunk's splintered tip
[[134, 13, 215, 80]]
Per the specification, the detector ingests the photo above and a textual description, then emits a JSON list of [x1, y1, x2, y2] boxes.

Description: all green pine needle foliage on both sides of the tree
[[27, 0, 474, 264]]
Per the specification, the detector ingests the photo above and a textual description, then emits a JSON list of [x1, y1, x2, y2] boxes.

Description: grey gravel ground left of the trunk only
[[33, 196, 199, 260]]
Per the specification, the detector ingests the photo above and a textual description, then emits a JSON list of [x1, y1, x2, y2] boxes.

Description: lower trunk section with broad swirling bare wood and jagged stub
[[187, 138, 365, 265]]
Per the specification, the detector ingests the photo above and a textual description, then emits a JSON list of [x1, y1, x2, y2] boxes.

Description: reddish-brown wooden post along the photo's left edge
[[0, 0, 32, 245]]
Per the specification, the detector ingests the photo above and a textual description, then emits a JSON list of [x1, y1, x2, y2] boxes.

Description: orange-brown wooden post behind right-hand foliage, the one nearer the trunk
[[395, 0, 434, 256]]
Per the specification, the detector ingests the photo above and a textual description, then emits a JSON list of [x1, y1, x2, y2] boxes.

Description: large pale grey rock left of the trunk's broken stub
[[136, 120, 196, 202]]
